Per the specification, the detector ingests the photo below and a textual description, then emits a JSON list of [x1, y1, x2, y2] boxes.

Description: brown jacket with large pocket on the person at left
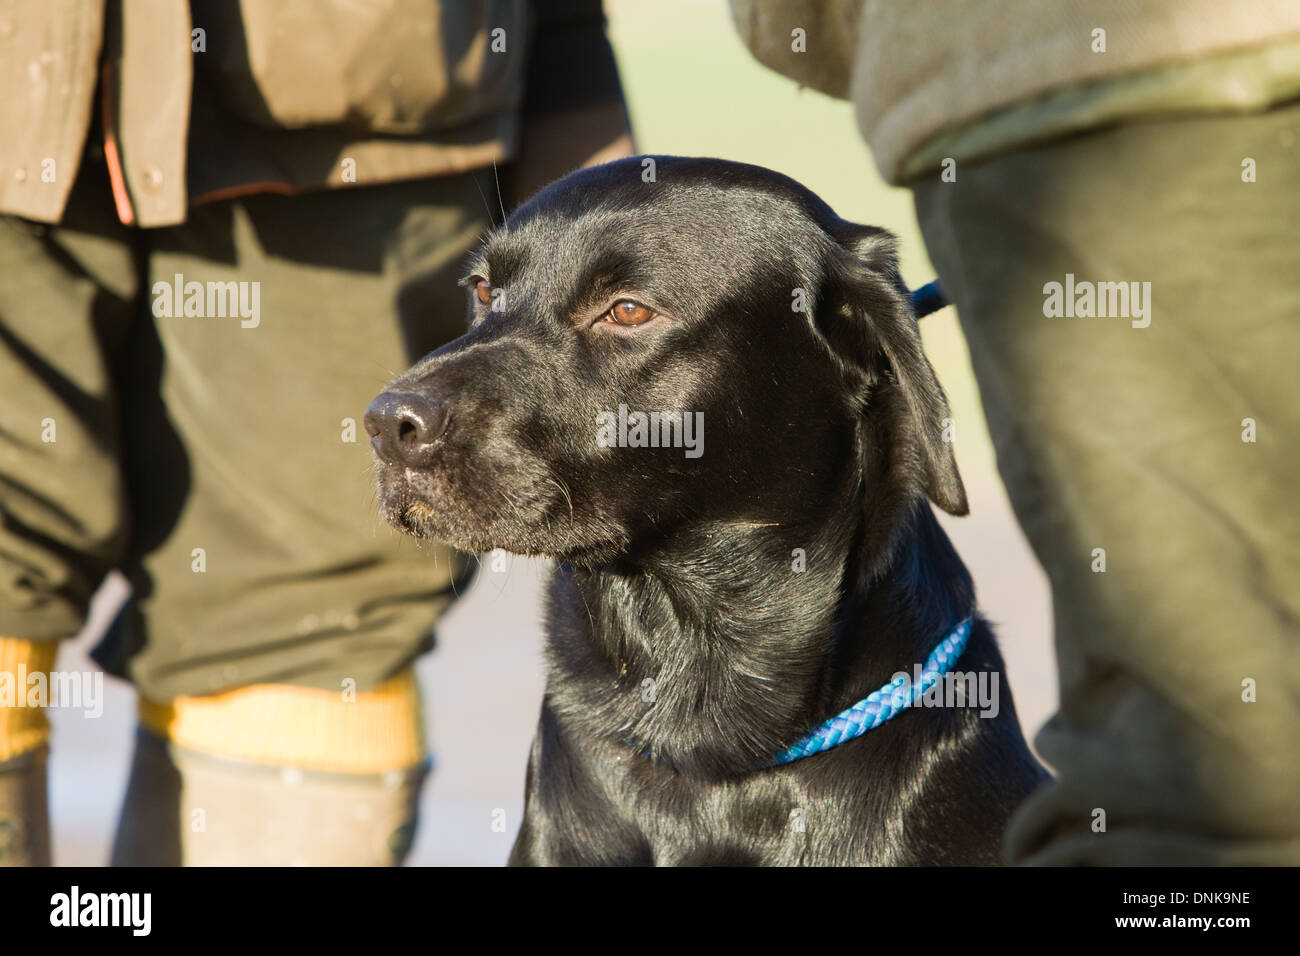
[[0, 0, 529, 226]]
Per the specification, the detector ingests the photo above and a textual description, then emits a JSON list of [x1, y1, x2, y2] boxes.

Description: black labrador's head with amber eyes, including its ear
[[365, 156, 966, 564]]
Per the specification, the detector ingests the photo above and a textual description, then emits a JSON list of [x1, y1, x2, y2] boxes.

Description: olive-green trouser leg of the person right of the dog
[[915, 98, 1300, 864]]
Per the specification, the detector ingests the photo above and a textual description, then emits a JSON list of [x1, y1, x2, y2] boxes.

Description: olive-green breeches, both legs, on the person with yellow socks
[[0, 143, 489, 701]]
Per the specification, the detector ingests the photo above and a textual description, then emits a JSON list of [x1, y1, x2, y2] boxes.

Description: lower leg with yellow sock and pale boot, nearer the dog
[[112, 670, 428, 866]]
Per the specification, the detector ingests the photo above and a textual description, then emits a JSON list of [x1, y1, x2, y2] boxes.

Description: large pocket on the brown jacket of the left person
[[192, 0, 528, 135]]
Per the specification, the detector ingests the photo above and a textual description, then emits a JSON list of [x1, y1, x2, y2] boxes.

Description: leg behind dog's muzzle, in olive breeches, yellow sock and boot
[[106, 176, 489, 864]]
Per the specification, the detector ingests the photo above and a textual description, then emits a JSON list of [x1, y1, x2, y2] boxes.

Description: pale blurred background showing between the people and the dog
[[51, 0, 1056, 866]]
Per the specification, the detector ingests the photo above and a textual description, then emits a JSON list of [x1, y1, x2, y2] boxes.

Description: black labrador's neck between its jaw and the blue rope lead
[[547, 486, 972, 777]]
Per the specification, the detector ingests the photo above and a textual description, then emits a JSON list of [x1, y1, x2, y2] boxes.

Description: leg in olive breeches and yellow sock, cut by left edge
[[0, 141, 138, 865]]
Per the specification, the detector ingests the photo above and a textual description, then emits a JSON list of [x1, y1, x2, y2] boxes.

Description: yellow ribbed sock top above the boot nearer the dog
[[139, 669, 425, 774]]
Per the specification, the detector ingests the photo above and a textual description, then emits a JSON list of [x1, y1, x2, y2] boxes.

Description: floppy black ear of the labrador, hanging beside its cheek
[[816, 224, 969, 515]]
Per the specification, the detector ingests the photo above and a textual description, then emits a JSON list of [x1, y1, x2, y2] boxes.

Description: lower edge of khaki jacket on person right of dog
[[731, 0, 1300, 183]]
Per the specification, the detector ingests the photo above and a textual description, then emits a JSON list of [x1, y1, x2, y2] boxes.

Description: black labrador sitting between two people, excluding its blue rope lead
[[365, 156, 1045, 865]]
